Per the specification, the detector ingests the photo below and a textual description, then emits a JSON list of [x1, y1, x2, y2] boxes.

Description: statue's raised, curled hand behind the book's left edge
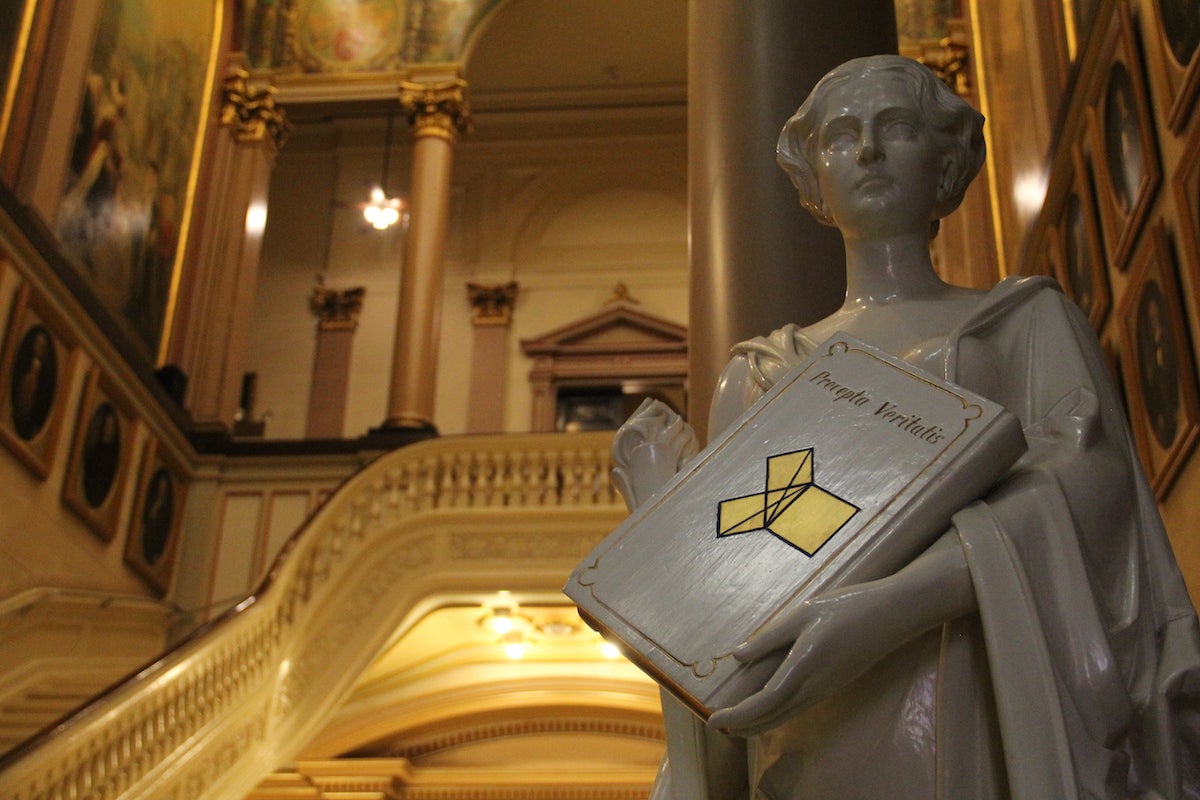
[[612, 398, 700, 511]]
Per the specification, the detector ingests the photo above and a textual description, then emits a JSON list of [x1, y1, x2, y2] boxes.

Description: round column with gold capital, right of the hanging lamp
[[383, 79, 469, 429]]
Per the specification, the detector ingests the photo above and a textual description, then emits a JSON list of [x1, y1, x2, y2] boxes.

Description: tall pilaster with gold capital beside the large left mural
[[163, 56, 289, 431]]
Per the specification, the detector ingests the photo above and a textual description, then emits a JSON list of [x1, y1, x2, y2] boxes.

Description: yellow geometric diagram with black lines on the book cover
[[716, 447, 859, 557]]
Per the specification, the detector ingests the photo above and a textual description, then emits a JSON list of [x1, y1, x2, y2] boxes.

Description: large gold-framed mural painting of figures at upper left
[[55, 0, 228, 360]]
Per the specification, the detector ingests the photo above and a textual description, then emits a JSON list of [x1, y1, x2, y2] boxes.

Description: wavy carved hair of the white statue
[[775, 55, 986, 224]]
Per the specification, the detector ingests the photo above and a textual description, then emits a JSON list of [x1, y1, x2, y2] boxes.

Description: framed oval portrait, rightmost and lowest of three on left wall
[[125, 441, 186, 594]]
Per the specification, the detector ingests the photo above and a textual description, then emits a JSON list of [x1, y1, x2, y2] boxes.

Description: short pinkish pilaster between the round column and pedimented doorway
[[467, 281, 517, 433]]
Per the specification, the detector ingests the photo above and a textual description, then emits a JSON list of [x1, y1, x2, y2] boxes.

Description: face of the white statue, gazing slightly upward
[[815, 72, 946, 235]]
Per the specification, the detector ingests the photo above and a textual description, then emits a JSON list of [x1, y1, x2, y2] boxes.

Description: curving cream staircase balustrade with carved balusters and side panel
[[0, 433, 624, 800]]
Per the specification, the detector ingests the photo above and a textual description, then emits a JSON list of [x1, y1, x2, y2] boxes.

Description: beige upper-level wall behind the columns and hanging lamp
[[248, 109, 688, 438]]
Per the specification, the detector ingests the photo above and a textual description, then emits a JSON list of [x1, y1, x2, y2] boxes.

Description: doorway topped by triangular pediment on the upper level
[[521, 299, 688, 431]]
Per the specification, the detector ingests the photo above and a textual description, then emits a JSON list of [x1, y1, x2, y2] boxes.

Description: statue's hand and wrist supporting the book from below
[[709, 533, 976, 736]]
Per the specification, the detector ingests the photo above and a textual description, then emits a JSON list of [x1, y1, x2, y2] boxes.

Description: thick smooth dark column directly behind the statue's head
[[688, 0, 896, 437]]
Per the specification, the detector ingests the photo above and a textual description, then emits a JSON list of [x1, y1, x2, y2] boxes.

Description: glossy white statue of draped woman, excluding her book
[[614, 56, 1200, 800]]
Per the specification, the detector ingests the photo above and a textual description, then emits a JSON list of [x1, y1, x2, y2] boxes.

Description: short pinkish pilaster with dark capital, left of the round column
[[305, 285, 366, 439]]
